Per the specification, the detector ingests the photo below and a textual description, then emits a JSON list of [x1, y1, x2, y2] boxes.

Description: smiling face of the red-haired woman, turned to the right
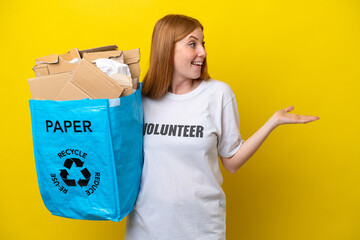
[[173, 28, 206, 81]]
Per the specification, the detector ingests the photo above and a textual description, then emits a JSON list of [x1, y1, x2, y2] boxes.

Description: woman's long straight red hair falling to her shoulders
[[142, 14, 210, 99]]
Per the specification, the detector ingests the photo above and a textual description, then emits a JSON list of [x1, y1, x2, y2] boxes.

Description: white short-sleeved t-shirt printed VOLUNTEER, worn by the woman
[[125, 79, 244, 240]]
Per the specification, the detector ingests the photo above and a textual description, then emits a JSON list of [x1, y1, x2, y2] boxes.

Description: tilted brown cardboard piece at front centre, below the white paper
[[57, 59, 124, 100]]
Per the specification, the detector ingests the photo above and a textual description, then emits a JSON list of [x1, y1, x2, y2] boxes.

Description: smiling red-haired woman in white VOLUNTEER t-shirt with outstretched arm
[[125, 15, 319, 240]]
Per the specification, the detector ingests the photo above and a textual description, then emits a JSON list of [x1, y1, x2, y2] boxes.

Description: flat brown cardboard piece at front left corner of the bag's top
[[28, 72, 72, 100]]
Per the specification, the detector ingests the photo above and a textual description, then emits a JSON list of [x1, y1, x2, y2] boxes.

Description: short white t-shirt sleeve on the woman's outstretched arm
[[218, 95, 245, 157]]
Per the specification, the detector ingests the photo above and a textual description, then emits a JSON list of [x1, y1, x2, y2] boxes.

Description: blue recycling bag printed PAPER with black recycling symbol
[[29, 88, 143, 221]]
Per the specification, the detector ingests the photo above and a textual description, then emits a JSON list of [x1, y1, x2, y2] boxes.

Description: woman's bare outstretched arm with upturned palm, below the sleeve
[[221, 106, 319, 173]]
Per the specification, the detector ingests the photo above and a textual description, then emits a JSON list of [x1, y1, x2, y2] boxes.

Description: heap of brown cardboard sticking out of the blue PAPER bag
[[28, 45, 140, 100]]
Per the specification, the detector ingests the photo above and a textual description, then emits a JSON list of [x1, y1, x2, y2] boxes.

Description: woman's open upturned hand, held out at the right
[[272, 106, 320, 125]]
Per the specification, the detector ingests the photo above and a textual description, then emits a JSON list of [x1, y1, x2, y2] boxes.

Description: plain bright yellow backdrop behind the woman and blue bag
[[0, 0, 360, 240]]
